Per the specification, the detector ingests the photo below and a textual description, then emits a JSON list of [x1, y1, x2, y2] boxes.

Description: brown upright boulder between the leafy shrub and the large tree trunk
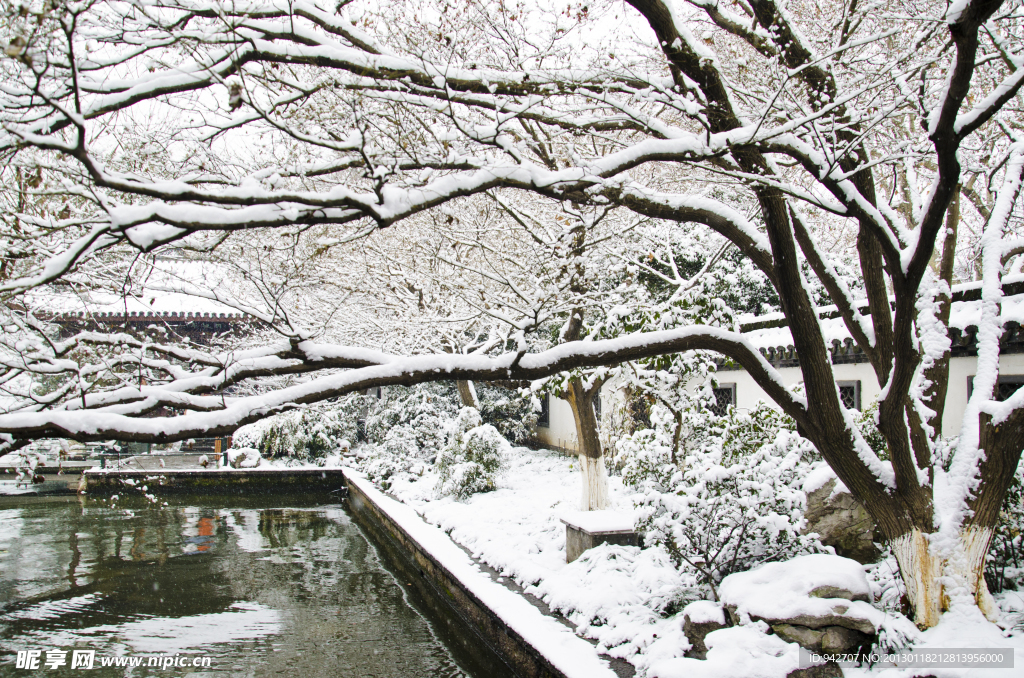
[[804, 478, 882, 565]]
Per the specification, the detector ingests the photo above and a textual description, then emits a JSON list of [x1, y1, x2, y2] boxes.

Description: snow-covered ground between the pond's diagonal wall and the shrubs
[[358, 448, 1024, 678]]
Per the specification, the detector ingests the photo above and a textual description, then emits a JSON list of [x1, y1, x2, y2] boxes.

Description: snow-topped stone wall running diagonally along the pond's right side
[[344, 469, 615, 678]]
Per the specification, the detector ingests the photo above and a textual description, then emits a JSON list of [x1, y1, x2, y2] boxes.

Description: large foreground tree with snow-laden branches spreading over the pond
[[0, 0, 1024, 626]]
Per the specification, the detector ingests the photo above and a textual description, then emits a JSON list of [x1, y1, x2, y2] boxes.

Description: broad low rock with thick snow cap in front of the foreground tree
[[719, 554, 884, 651]]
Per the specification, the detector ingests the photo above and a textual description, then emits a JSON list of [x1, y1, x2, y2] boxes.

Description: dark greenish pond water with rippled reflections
[[0, 497, 484, 678]]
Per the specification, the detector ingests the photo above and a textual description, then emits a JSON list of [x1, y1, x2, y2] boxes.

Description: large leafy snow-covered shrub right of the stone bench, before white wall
[[618, 405, 826, 597]]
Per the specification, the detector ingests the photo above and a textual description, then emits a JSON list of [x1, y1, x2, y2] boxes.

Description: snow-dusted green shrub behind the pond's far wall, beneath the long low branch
[[232, 394, 368, 462]]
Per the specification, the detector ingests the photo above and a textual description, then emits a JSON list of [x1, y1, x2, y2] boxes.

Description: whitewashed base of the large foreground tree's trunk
[[891, 526, 998, 629]]
